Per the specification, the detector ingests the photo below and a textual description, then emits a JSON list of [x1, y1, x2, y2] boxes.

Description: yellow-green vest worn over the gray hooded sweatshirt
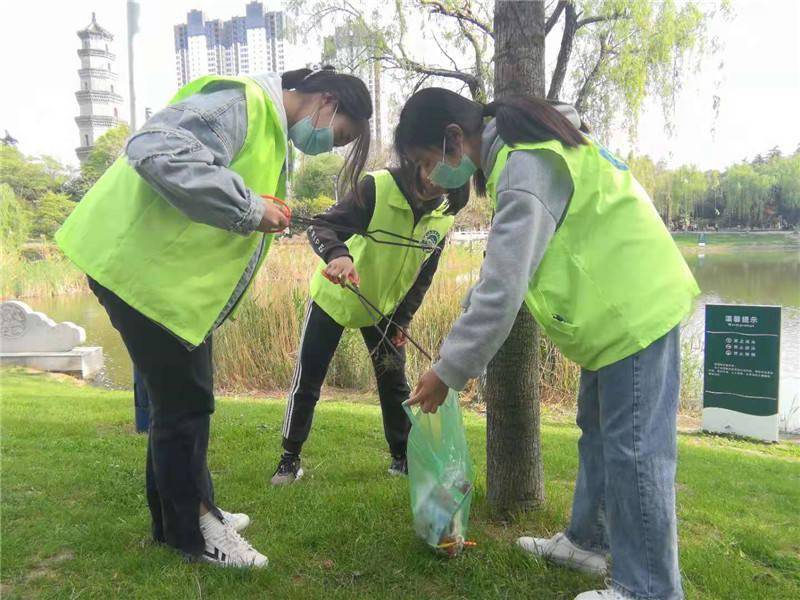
[[487, 140, 700, 370]]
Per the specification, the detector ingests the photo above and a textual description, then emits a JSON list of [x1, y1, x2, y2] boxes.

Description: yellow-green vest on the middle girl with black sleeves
[[311, 170, 454, 329]]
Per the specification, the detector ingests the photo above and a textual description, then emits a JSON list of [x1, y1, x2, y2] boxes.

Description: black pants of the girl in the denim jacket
[[89, 279, 221, 555]]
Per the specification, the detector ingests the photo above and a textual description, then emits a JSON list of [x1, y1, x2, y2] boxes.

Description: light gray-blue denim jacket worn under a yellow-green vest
[[125, 73, 287, 344]]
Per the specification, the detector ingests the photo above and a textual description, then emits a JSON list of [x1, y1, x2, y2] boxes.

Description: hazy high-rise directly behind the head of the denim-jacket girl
[[322, 21, 383, 148]]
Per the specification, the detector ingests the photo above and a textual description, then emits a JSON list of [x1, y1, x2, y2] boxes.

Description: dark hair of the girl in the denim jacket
[[281, 66, 372, 197]]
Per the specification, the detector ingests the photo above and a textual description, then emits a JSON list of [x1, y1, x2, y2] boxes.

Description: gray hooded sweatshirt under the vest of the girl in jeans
[[433, 119, 580, 390]]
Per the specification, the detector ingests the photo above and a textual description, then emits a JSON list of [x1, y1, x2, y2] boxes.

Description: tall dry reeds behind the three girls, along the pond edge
[[214, 243, 592, 404]]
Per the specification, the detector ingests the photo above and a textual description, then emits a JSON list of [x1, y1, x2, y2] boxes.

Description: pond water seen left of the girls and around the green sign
[[28, 234, 800, 431]]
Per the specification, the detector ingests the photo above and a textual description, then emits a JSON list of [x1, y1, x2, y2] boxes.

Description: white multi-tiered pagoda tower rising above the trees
[[75, 13, 122, 162]]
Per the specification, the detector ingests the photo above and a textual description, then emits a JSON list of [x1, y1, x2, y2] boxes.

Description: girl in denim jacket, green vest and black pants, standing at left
[[56, 69, 372, 567]]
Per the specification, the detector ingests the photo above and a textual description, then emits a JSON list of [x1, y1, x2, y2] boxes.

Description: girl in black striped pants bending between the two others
[[272, 168, 469, 485]]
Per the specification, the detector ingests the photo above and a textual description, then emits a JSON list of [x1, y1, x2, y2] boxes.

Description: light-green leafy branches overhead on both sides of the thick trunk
[[288, 0, 730, 134]]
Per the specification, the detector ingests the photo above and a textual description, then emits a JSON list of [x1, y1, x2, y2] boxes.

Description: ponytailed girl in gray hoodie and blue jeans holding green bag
[[395, 88, 699, 600]]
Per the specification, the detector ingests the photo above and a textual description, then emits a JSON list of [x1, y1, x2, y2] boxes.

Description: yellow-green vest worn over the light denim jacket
[[56, 76, 286, 346]]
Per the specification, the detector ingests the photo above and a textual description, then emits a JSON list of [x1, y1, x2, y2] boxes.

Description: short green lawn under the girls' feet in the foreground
[[0, 371, 800, 600]]
